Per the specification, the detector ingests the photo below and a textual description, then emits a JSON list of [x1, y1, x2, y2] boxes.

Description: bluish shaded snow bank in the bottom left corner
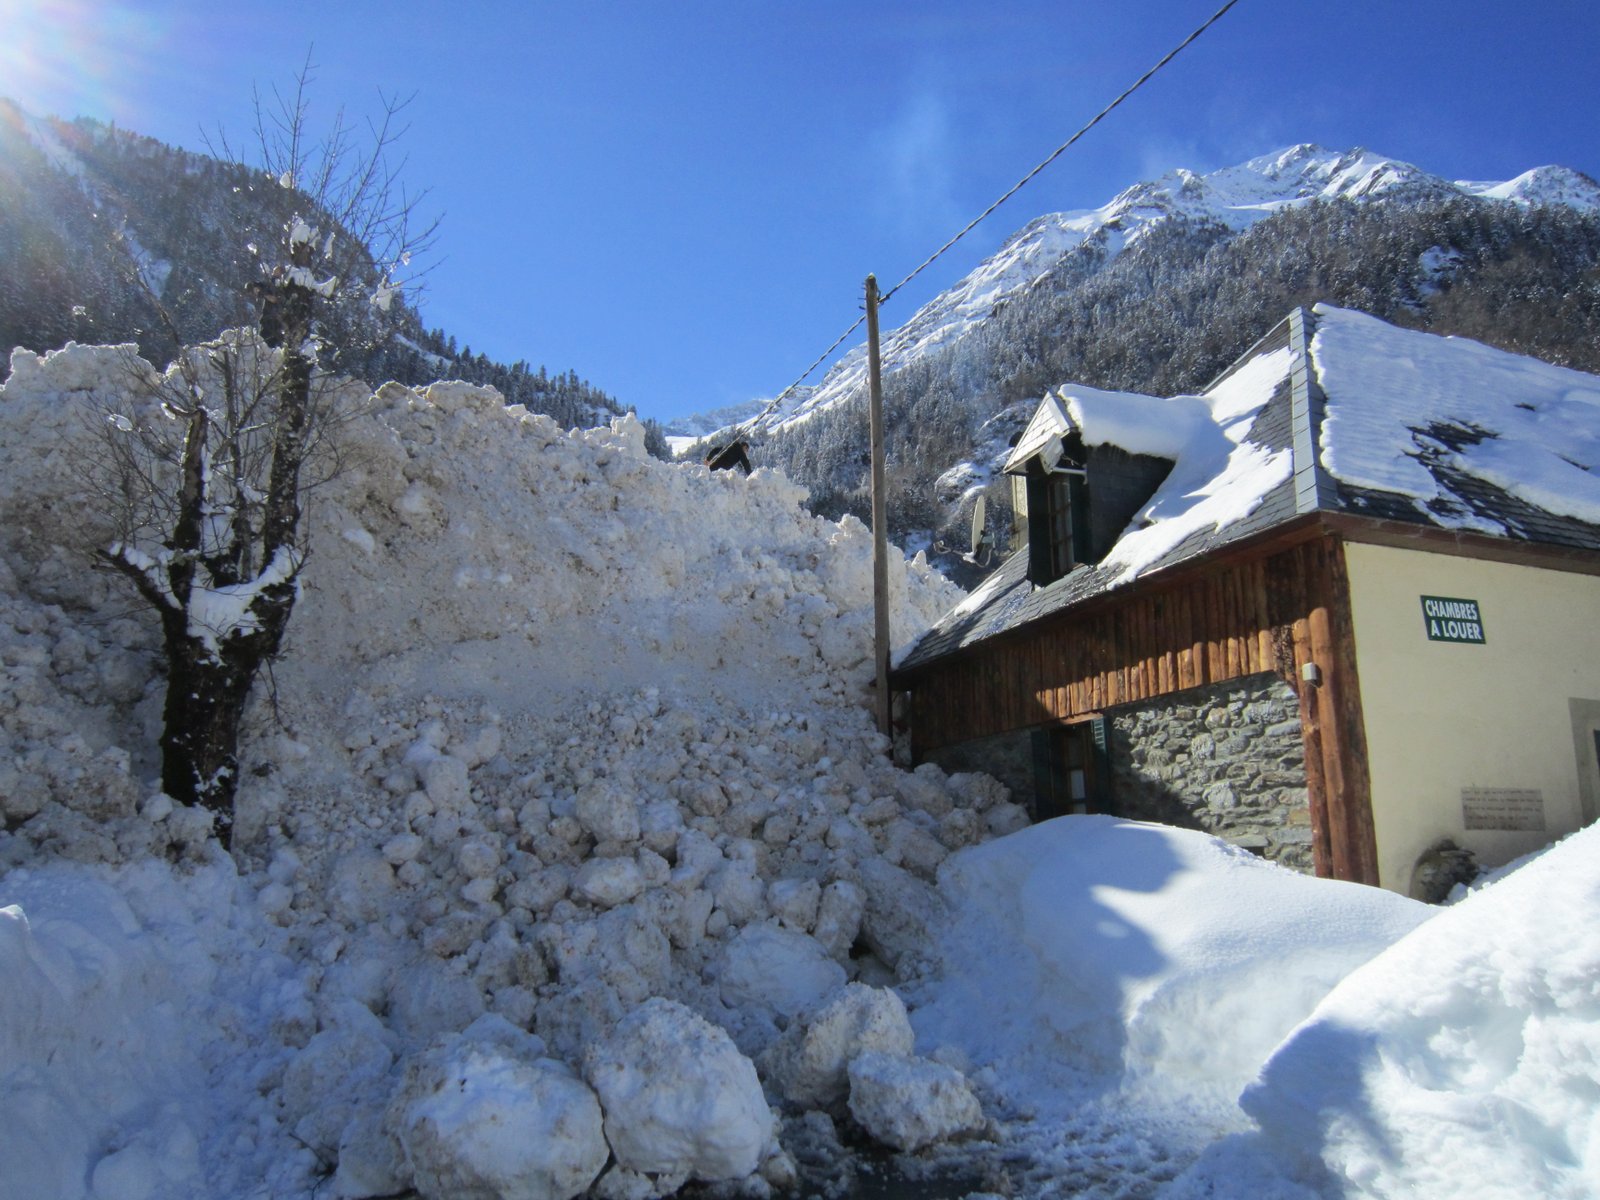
[[0, 854, 313, 1200]]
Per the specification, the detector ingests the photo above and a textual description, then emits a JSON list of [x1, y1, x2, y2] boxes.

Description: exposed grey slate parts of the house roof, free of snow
[[896, 302, 1600, 675]]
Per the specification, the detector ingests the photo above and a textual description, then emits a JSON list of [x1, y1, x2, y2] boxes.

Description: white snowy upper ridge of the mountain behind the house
[[729, 144, 1600, 430]]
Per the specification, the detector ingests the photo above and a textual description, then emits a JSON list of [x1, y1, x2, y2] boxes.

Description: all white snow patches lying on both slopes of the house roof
[[998, 304, 1600, 595]]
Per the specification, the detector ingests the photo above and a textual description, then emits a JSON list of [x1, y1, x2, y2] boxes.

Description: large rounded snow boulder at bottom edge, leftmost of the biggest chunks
[[392, 1018, 608, 1200]]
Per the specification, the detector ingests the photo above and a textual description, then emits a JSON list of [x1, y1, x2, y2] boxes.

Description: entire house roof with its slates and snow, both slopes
[[899, 306, 1600, 670]]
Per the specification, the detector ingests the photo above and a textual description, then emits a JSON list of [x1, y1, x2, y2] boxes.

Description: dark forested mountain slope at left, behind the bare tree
[[0, 98, 636, 426]]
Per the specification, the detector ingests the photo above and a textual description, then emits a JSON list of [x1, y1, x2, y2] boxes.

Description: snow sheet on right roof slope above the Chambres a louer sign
[[1312, 304, 1600, 525]]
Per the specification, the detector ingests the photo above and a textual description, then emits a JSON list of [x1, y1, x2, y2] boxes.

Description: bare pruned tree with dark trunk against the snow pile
[[93, 62, 437, 845]]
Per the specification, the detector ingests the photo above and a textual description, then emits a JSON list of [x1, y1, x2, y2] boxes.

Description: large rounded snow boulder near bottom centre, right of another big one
[[586, 998, 774, 1182]]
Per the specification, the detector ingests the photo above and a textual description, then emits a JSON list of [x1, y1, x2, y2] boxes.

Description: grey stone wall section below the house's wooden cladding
[[1107, 674, 1312, 872]]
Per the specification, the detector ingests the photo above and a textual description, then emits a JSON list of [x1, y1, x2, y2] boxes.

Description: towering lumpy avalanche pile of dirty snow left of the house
[[0, 346, 1019, 1200]]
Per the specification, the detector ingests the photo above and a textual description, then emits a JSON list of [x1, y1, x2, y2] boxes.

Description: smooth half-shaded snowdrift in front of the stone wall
[[912, 816, 1434, 1098]]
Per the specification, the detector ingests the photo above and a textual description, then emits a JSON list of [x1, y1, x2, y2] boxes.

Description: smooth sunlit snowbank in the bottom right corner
[[1242, 827, 1600, 1198]]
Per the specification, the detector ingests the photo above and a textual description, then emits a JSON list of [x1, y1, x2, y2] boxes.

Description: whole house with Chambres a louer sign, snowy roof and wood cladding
[[891, 306, 1600, 893]]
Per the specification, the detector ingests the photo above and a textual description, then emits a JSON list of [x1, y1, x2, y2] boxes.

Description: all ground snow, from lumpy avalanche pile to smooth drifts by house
[[0, 347, 1600, 1200]]
